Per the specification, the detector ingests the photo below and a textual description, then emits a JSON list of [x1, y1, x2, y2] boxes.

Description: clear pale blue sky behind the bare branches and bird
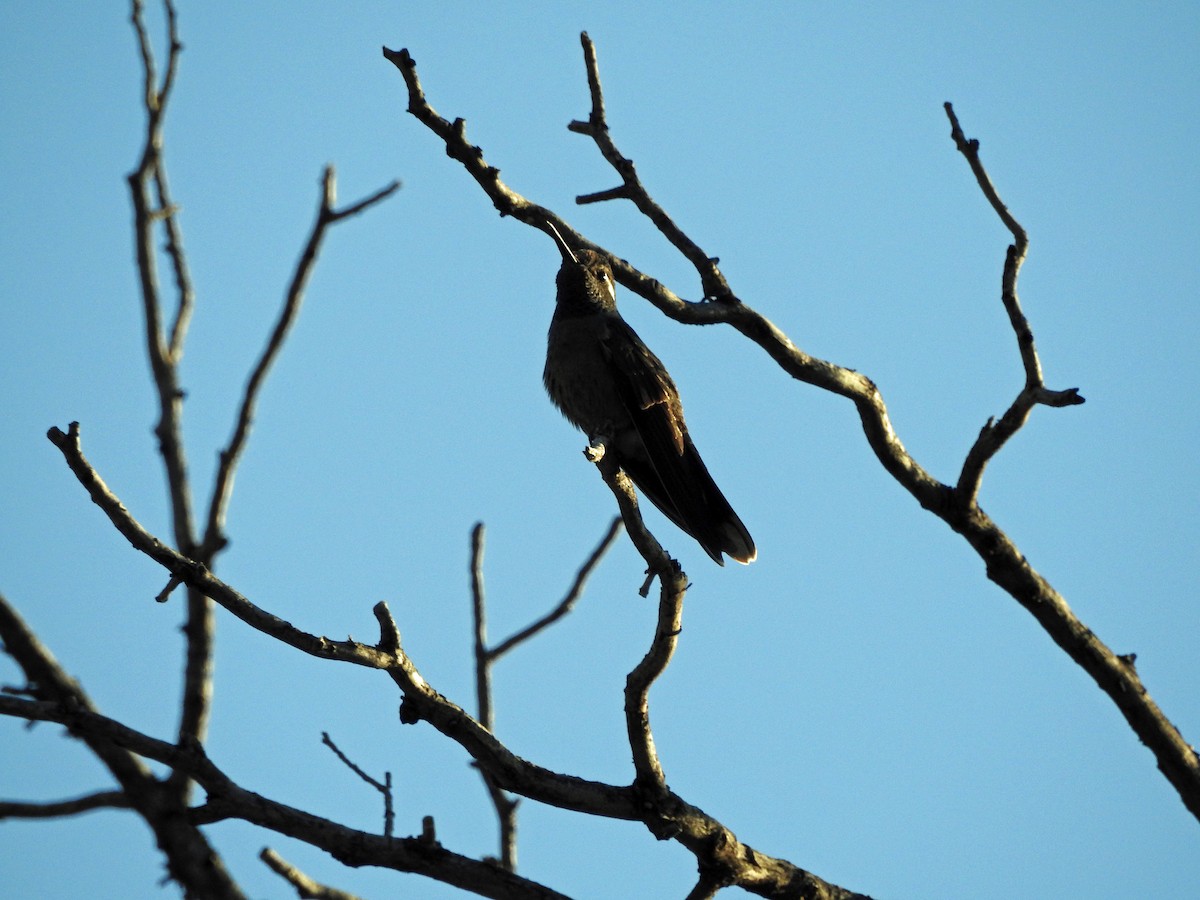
[[0, 0, 1200, 900]]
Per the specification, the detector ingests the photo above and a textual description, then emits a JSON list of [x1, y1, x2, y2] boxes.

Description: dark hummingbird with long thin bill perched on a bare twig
[[542, 222, 758, 565]]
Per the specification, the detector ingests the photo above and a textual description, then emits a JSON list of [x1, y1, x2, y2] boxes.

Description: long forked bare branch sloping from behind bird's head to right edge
[[383, 37, 1200, 817]]
